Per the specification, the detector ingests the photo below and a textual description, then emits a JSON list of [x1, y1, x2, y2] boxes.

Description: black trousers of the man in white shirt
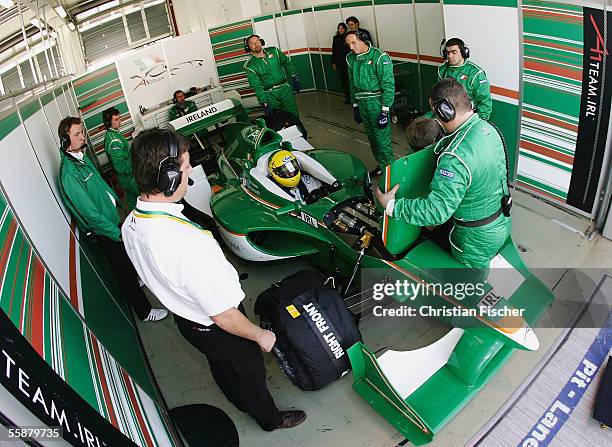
[[174, 309, 282, 431]]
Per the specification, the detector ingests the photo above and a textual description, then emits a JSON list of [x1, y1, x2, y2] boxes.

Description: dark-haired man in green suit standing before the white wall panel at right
[[438, 37, 493, 120]]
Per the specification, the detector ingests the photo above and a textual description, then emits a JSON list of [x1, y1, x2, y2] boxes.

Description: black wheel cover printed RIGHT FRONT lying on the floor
[[255, 270, 361, 391]]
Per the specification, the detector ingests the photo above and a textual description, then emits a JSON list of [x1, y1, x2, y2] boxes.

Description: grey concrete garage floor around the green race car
[[139, 93, 612, 447]]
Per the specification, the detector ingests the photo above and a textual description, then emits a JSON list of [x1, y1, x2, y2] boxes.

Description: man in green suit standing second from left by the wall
[[102, 107, 140, 210]]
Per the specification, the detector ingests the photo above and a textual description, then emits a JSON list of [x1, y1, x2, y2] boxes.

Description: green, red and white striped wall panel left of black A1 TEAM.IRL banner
[[518, 0, 583, 204]]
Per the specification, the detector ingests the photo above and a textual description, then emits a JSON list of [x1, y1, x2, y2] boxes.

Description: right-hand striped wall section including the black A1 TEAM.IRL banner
[[518, 0, 612, 215]]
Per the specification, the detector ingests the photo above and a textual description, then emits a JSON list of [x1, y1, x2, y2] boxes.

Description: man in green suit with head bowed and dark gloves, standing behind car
[[344, 31, 395, 177]]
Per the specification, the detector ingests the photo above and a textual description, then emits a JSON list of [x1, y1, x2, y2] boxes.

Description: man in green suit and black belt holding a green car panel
[[375, 78, 512, 268]]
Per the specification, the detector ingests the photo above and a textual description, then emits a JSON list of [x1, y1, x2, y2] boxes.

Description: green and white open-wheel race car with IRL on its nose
[[176, 100, 554, 445]]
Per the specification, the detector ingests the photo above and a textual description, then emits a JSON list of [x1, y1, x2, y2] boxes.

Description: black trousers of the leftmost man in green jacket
[[95, 235, 151, 320]]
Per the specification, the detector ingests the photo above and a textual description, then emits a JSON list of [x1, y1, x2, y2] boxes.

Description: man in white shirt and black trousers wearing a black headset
[[121, 129, 306, 431]]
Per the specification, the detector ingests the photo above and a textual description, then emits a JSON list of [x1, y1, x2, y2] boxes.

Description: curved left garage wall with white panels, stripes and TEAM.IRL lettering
[[0, 84, 177, 446]]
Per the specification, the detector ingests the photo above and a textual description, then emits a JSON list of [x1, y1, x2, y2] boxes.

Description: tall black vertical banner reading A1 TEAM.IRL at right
[[567, 8, 612, 213]]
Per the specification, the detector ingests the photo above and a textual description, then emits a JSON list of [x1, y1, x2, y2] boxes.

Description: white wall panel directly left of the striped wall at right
[[442, 5, 521, 91]]
